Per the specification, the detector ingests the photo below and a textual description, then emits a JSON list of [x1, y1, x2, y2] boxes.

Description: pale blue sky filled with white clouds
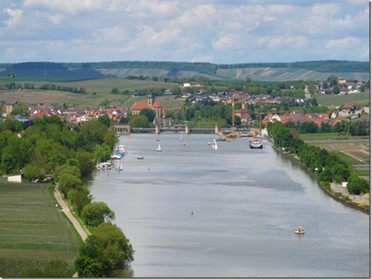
[[0, 0, 369, 64]]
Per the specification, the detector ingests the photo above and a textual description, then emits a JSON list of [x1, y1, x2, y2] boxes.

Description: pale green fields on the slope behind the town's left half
[[0, 78, 183, 110]]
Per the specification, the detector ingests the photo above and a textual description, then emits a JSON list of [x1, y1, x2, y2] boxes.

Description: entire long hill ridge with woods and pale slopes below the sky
[[0, 60, 369, 81]]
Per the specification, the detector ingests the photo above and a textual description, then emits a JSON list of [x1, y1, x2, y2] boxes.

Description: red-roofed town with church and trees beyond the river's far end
[[0, 76, 369, 138]]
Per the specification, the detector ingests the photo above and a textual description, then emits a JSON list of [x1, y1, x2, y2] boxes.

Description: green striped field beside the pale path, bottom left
[[0, 180, 79, 277]]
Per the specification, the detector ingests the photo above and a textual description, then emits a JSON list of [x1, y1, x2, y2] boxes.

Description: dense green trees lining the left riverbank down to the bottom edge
[[0, 116, 134, 277]]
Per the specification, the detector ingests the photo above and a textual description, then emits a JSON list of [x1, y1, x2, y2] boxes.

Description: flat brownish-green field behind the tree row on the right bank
[[300, 134, 370, 181]]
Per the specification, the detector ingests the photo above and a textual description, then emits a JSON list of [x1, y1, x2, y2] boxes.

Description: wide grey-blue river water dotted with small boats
[[90, 134, 370, 277]]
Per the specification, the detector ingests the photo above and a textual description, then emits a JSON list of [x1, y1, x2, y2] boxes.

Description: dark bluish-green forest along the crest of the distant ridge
[[0, 60, 369, 79]]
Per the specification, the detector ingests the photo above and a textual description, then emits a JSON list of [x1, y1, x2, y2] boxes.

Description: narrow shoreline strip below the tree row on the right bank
[[270, 143, 370, 215]]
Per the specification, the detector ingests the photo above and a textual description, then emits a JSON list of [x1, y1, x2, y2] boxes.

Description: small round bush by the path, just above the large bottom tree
[[81, 202, 115, 227]]
